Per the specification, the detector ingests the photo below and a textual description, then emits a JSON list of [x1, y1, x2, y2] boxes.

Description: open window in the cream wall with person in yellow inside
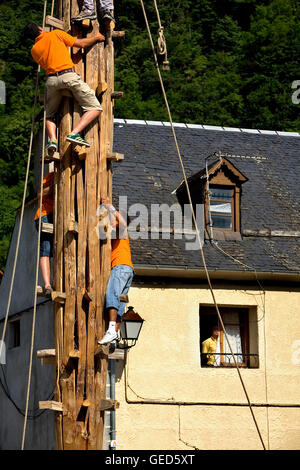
[[200, 306, 259, 368]]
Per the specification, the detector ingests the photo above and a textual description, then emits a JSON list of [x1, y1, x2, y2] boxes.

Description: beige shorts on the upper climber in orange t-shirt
[[45, 72, 102, 119]]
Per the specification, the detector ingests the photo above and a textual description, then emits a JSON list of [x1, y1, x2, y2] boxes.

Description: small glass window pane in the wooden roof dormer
[[209, 186, 234, 230]]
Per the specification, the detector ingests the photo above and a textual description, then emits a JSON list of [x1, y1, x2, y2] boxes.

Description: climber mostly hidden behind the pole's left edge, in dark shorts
[[34, 172, 54, 296]]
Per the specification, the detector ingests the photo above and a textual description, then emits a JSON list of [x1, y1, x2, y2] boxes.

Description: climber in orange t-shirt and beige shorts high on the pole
[[24, 23, 105, 152]]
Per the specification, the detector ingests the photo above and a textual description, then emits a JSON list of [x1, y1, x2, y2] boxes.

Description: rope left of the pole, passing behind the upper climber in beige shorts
[[21, 0, 47, 450]]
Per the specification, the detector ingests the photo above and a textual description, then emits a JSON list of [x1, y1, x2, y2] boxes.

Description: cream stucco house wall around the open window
[[116, 286, 300, 450]]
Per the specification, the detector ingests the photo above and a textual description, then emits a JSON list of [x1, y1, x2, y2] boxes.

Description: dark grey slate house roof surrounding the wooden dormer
[[113, 120, 300, 274]]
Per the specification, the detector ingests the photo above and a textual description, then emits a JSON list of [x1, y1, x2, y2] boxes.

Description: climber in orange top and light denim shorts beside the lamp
[[98, 198, 134, 344]]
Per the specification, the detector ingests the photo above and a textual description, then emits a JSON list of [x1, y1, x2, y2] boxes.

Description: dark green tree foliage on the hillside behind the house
[[0, 0, 300, 267]]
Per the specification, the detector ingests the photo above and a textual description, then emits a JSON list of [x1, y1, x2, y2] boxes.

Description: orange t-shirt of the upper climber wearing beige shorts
[[31, 29, 77, 75]]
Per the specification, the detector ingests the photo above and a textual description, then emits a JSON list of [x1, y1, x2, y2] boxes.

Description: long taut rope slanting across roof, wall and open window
[[140, 0, 266, 450]]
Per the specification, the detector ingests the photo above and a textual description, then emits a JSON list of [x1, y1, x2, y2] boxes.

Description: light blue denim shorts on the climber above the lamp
[[105, 264, 134, 320]]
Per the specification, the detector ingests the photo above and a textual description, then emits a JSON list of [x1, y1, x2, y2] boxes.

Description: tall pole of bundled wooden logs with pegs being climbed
[[53, 0, 114, 450]]
